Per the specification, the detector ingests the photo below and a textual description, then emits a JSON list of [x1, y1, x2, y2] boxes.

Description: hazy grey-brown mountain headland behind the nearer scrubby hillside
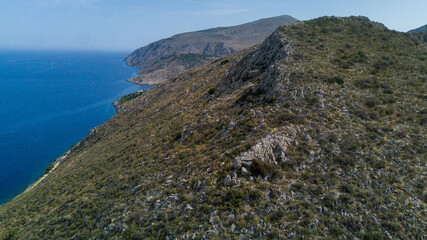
[[125, 15, 298, 84]]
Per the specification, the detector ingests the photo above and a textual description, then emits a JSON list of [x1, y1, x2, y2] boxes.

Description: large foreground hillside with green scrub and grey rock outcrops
[[0, 17, 427, 239]]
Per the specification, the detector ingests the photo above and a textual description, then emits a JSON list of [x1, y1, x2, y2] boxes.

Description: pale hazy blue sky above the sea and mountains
[[0, 0, 427, 52]]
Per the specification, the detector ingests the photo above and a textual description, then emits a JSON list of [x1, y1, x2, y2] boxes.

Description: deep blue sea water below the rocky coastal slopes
[[0, 50, 148, 204]]
